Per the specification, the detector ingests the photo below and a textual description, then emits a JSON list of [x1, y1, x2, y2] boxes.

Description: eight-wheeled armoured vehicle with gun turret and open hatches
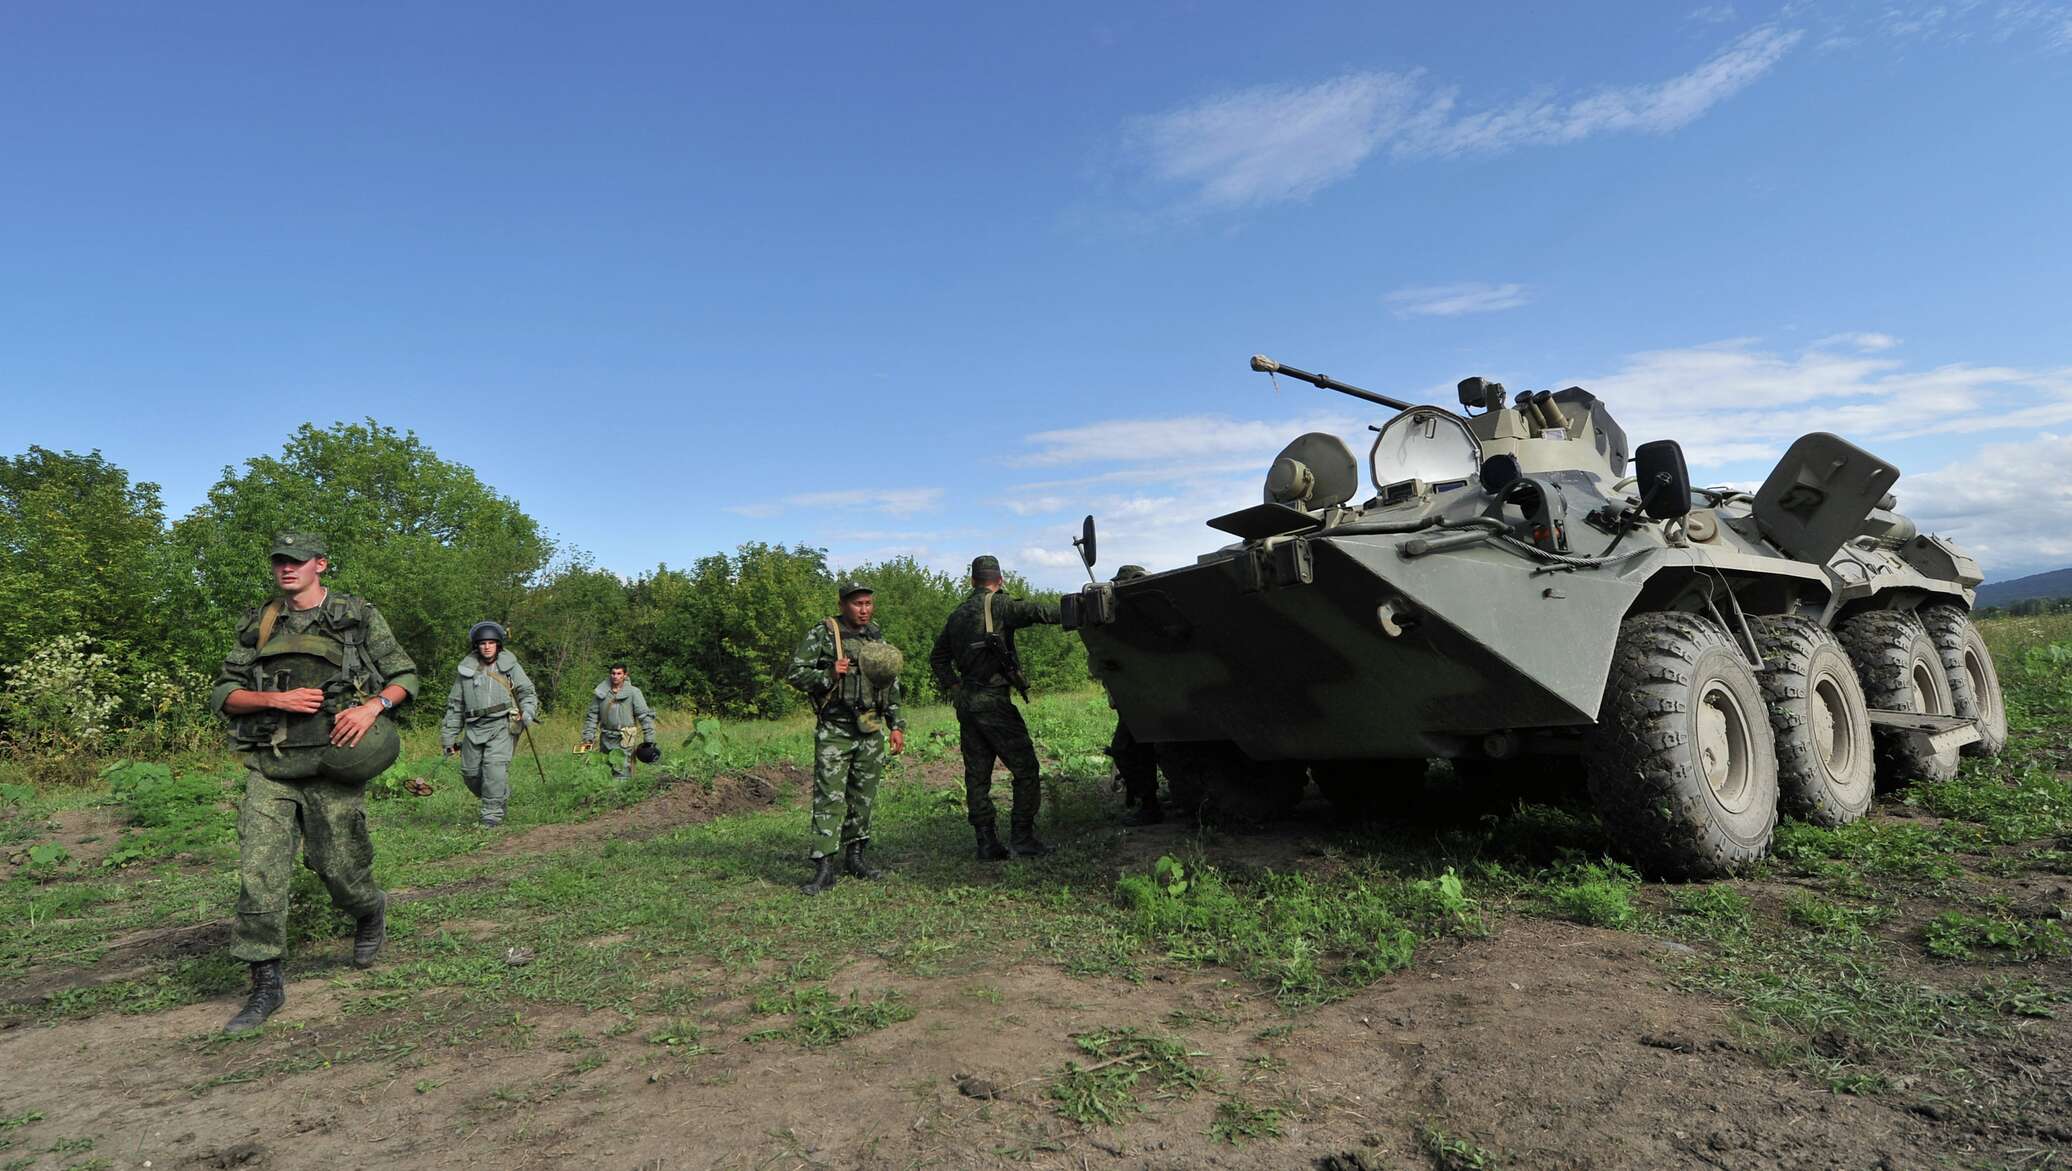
[[1065, 356, 2008, 877]]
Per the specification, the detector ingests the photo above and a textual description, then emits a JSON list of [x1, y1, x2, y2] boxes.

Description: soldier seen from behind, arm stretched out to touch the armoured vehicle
[[928, 558, 1059, 860]]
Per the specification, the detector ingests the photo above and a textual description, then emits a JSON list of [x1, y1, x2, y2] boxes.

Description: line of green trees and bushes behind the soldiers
[[0, 419, 1086, 752]]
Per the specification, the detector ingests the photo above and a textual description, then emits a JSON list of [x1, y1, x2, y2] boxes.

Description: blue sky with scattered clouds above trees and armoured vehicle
[[0, 0, 2072, 584]]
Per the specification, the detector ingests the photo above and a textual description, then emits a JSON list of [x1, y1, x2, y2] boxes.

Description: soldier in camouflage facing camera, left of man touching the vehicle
[[783, 580, 905, 895]]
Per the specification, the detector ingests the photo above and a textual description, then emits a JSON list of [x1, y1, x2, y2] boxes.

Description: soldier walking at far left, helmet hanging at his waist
[[209, 533, 416, 1032]]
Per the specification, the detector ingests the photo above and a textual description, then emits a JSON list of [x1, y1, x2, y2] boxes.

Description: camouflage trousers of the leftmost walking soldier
[[230, 769, 381, 964]]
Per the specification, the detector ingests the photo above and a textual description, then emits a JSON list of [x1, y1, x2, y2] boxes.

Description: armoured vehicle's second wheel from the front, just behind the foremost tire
[[1755, 618, 1877, 827]]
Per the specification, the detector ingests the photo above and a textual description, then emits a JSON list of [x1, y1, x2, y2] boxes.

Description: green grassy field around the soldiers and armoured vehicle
[[0, 616, 2072, 1169]]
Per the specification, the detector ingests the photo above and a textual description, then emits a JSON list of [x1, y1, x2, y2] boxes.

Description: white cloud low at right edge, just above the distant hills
[[1898, 433, 2072, 578]]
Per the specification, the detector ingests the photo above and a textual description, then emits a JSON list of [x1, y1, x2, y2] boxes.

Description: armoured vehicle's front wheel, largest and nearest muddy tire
[[1585, 613, 1778, 879]]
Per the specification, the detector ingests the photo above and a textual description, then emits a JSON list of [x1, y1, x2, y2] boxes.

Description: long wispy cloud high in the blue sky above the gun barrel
[[1123, 25, 1801, 211]]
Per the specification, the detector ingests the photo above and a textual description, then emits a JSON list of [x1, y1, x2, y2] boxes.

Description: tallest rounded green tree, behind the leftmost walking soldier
[[172, 419, 553, 690]]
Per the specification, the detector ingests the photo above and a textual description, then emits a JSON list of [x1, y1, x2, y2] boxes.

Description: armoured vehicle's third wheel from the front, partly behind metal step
[[1840, 609, 1956, 790]]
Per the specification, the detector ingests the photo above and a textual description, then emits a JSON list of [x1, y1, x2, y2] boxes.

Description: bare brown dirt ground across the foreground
[[0, 773, 2072, 1171]]
